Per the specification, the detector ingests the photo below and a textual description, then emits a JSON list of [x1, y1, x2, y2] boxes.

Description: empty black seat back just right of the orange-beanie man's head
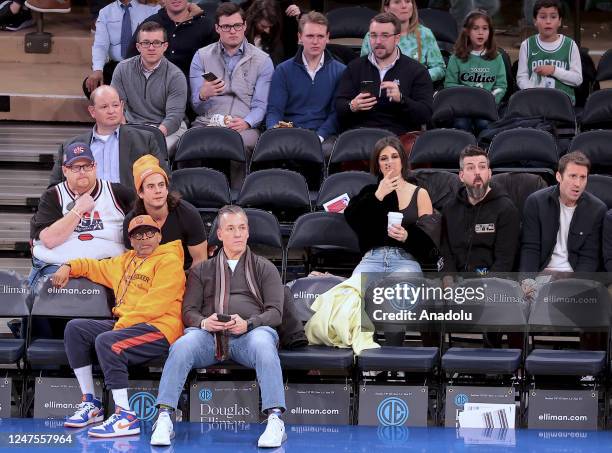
[[172, 168, 231, 235]]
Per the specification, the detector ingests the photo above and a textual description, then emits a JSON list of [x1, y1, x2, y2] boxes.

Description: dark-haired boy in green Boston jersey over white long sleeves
[[516, 0, 582, 104]]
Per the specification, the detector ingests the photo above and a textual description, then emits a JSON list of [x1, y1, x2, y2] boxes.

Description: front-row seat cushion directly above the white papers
[[442, 348, 521, 374]]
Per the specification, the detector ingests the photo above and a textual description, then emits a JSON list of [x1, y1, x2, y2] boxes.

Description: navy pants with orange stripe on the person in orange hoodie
[[64, 319, 170, 389]]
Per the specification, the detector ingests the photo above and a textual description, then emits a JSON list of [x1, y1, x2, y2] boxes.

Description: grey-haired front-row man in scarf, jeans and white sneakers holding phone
[[151, 205, 286, 447]]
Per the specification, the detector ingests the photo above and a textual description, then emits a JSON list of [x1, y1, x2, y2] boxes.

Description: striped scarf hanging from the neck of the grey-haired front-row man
[[215, 246, 264, 361]]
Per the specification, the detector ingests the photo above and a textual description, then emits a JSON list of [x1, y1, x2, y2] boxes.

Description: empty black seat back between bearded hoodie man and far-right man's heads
[[489, 128, 559, 184]]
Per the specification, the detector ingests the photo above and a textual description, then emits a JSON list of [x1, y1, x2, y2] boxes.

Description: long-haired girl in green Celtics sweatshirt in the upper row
[[444, 10, 508, 136]]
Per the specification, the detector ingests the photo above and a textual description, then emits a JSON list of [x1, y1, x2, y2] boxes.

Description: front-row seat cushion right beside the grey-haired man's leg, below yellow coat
[[278, 346, 353, 370]]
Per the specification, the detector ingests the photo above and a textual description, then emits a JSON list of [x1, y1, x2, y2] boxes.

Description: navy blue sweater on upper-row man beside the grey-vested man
[[266, 48, 345, 138]]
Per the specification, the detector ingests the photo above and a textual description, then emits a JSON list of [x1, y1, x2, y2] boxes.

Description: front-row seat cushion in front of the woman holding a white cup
[[357, 346, 440, 373]]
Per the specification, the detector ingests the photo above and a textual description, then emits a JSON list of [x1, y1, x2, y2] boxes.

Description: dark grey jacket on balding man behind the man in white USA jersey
[[48, 125, 168, 191]]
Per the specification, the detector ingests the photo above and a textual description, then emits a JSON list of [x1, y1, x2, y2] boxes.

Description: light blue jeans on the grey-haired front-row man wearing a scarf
[[157, 326, 285, 411]]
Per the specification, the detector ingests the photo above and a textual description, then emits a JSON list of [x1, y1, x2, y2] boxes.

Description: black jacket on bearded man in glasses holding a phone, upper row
[[336, 53, 433, 135]]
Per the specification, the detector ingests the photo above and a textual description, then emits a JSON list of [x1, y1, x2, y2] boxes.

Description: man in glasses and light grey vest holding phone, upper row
[[189, 2, 274, 187]]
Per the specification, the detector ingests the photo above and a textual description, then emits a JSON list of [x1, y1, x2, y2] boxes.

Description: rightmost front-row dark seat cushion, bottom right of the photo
[[525, 349, 606, 376]]
